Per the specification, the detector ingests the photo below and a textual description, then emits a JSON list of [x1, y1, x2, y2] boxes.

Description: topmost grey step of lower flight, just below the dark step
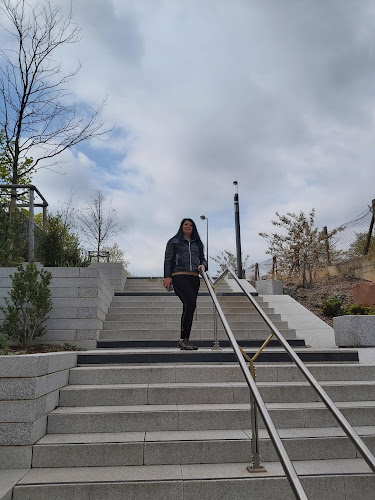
[[69, 363, 375, 385]]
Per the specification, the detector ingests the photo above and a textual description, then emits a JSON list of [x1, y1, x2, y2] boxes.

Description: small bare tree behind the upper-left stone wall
[[77, 189, 123, 262]]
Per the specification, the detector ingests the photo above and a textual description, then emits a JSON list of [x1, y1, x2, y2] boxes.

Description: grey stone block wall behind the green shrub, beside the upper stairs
[[0, 267, 114, 349]]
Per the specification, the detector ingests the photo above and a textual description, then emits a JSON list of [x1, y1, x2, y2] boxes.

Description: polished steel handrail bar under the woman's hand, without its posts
[[201, 271, 308, 500]]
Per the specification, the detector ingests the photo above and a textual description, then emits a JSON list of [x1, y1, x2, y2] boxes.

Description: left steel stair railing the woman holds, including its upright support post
[[201, 270, 308, 500]]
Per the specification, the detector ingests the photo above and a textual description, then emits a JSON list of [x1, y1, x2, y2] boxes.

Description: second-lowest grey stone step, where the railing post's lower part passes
[[32, 426, 375, 468]]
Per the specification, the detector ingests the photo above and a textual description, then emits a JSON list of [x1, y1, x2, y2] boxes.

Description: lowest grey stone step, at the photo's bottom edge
[[13, 459, 375, 500]]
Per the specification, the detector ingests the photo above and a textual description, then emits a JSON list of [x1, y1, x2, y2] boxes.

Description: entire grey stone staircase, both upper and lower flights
[[13, 279, 375, 500]]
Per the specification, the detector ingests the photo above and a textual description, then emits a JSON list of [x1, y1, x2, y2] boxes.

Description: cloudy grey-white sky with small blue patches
[[0, 0, 375, 276]]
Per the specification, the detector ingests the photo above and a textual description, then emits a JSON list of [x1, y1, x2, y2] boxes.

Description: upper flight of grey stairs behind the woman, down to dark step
[[87, 278, 358, 364]]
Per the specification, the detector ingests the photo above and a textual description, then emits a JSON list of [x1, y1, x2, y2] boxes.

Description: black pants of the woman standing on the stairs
[[172, 274, 200, 339]]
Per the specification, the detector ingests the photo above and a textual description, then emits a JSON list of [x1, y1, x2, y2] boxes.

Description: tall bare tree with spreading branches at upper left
[[0, 0, 110, 206]]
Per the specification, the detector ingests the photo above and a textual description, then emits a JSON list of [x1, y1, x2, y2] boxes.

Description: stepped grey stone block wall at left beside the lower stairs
[[0, 352, 77, 469]]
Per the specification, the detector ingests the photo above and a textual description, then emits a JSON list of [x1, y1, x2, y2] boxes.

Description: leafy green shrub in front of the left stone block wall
[[0, 262, 52, 348]]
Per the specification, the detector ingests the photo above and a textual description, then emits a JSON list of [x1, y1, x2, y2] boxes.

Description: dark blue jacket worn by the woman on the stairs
[[164, 236, 207, 278]]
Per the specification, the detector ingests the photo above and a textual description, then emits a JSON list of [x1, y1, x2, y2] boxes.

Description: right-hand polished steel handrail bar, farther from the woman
[[220, 268, 375, 472]]
